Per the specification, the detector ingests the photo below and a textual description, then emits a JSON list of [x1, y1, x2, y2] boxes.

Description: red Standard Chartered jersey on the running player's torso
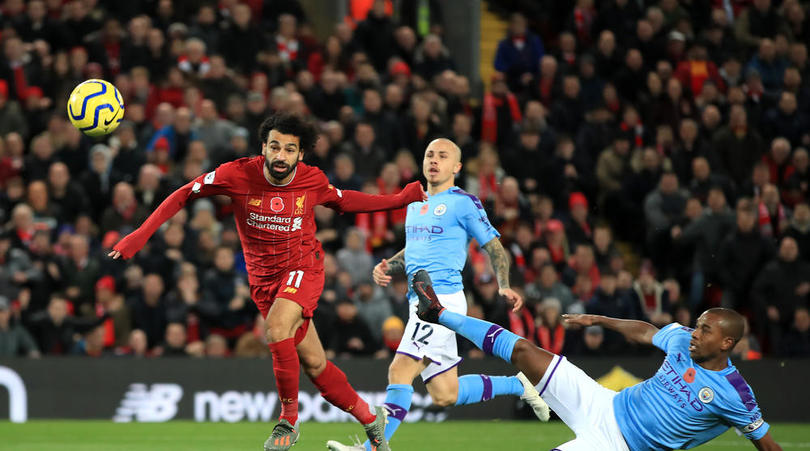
[[191, 156, 343, 285]]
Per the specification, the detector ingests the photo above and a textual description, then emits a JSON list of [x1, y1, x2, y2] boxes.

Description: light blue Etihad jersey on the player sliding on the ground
[[613, 323, 770, 450]]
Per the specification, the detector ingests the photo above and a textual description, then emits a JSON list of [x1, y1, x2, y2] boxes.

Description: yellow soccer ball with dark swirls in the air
[[68, 79, 124, 136]]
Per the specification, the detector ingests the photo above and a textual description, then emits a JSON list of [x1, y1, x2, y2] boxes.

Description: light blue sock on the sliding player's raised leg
[[439, 309, 521, 363]]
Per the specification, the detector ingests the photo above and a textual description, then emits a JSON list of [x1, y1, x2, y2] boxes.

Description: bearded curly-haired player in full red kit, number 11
[[109, 115, 427, 451]]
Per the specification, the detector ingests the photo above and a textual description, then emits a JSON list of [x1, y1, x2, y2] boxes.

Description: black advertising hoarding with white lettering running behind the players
[[0, 357, 810, 422]]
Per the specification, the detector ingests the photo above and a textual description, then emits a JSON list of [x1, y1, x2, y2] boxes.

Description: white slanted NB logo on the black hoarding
[[113, 384, 183, 423]]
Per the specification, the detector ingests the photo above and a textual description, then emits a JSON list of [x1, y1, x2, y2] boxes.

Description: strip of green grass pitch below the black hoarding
[[0, 421, 810, 451]]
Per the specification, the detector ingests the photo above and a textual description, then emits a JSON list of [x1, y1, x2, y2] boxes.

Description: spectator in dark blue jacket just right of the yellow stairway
[[494, 13, 545, 91]]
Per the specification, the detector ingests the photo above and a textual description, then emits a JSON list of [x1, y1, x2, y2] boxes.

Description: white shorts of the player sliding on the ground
[[536, 355, 629, 451]]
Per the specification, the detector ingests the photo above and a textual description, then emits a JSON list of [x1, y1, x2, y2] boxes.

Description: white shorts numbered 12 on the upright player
[[397, 291, 467, 382]]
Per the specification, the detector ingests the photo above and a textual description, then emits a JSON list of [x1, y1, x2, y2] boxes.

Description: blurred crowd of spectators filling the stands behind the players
[[0, 0, 810, 359]]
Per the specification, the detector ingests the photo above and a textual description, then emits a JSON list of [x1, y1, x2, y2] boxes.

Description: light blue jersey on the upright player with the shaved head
[[405, 186, 501, 298]]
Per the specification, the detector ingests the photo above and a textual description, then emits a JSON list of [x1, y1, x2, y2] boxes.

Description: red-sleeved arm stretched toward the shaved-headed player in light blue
[[320, 182, 427, 213]]
